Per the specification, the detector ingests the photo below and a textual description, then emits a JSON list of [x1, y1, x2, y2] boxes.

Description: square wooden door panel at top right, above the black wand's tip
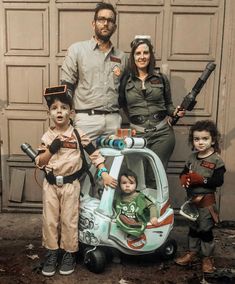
[[168, 7, 219, 61]]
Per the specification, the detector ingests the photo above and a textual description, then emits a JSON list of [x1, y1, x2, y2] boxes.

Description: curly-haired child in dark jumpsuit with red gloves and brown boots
[[175, 120, 226, 273]]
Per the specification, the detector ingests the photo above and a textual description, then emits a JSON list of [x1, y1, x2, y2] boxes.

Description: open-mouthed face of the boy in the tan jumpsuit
[[49, 100, 72, 128]]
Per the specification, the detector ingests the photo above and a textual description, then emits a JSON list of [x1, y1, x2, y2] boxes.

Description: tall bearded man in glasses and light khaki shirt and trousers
[[61, 3, 128, 140]]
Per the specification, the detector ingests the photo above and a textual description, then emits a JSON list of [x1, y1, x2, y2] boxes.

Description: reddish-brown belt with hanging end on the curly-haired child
[[191, 193, 219, 223]]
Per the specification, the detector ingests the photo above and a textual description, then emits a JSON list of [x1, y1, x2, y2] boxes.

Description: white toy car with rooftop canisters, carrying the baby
[[79, 137, 177, 273]]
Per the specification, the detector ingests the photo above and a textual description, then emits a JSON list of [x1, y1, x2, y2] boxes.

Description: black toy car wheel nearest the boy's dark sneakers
[[84, 248, 106, 273]]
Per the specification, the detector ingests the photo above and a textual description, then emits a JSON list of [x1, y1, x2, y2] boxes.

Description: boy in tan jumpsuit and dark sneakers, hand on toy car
[[36, 87, 117, 276]]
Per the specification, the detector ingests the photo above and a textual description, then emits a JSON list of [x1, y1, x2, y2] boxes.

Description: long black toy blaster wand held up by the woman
[[171, 62, 216, 125]]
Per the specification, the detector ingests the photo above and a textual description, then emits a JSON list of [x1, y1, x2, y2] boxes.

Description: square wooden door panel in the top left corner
[[5, 5, 49, 56]]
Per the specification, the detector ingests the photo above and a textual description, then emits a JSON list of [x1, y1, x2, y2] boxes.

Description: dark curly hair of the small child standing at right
[[188, 119, 221, 153]]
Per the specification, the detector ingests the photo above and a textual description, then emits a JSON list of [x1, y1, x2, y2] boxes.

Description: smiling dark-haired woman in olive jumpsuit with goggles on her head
[[119, 37, 185, 186]]
